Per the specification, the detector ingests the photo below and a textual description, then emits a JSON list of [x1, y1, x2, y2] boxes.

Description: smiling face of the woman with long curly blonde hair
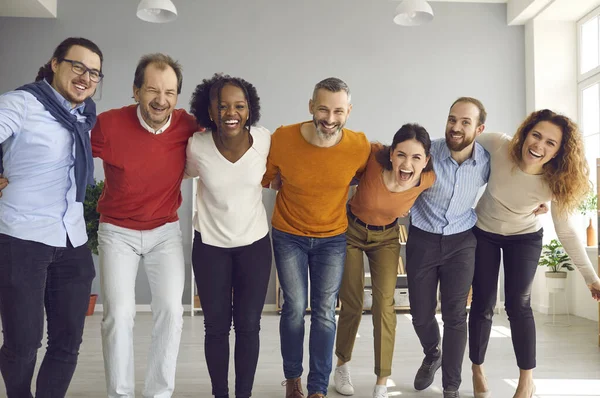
[[521, 121, 563, 170]]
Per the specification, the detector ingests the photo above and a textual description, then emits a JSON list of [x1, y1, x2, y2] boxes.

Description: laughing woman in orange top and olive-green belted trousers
[[334, 124, 435, 398]]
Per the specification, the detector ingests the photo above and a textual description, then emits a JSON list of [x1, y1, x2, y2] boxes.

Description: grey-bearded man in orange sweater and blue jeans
[[263, 78, 371, 398]]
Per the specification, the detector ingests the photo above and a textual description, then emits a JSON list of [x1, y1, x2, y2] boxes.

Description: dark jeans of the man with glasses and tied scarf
[[0, 234, 95, 398]]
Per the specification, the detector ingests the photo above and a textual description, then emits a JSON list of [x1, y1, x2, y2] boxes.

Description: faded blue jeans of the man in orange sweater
[[273, 228, 346, 395]]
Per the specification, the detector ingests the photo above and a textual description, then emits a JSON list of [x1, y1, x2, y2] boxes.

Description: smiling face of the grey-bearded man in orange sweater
[[308, 89, 352, 141]]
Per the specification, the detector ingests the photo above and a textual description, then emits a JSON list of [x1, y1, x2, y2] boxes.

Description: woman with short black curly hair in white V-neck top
[[185, 74, 271, 398]]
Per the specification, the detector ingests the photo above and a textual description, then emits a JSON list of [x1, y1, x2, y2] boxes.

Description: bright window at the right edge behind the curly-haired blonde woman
[[577, 8, 600, 191]]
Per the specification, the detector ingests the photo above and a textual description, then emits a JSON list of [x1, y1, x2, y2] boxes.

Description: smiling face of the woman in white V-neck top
[[208, 84, 250, 137]]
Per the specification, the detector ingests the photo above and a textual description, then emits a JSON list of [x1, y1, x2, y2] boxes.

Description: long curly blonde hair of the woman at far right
[[509, 109, 591, 215]]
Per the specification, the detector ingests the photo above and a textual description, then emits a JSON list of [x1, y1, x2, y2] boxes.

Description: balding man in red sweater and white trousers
[[91, 54, 198, 398]]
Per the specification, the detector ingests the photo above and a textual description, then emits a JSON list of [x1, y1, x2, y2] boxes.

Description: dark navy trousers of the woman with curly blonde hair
[[469, 228, 544, 370]]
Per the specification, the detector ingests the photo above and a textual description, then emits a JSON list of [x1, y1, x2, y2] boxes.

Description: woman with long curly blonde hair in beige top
[[469, 109, 600, 398]]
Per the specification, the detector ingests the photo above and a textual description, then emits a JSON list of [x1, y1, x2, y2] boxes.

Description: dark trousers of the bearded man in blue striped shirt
[[406, 226, 477, 390]]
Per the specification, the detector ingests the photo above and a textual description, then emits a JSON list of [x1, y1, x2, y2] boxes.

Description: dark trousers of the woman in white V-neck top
[[192, 231, 272, 398]]
